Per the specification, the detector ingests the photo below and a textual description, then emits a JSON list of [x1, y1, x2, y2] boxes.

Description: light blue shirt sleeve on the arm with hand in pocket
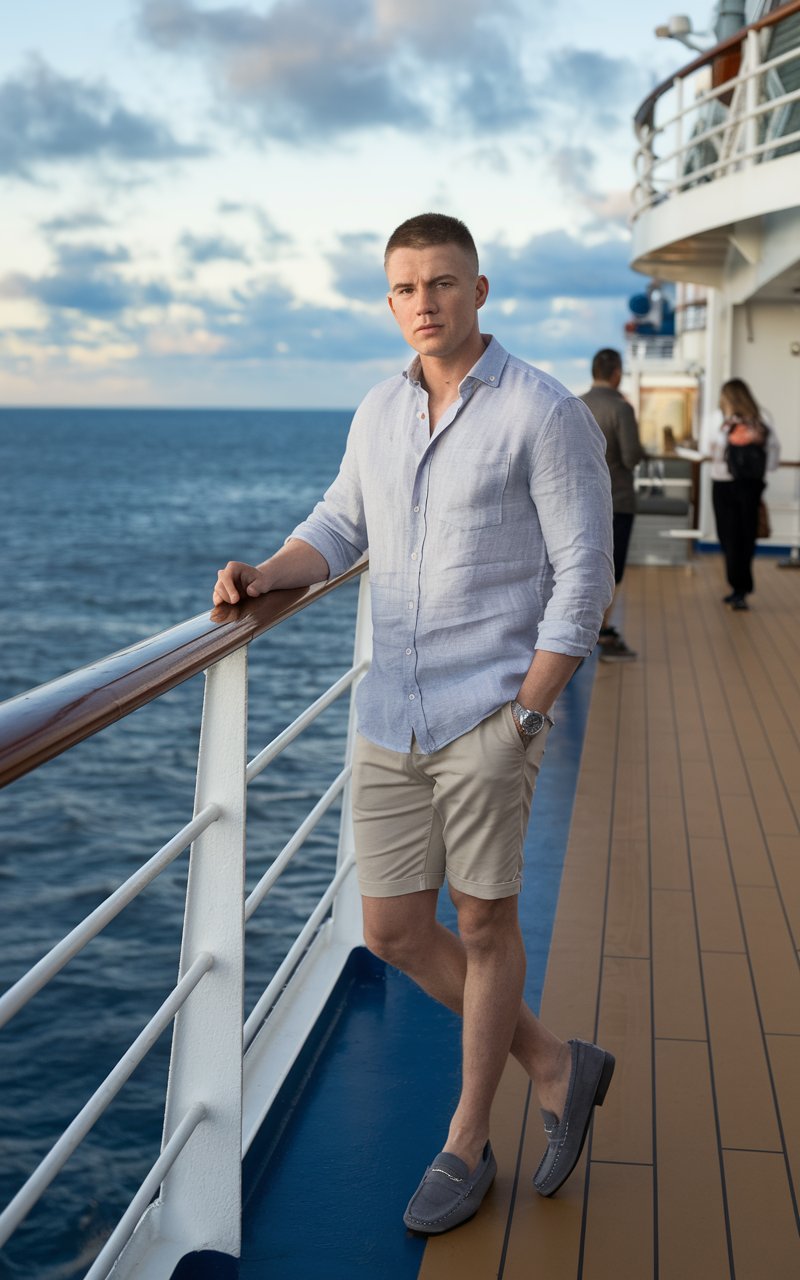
[[530, 398, 614, 657]]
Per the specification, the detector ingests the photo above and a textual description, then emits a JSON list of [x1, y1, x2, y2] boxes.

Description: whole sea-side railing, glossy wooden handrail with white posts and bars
[[0, 561, 371, 1280]]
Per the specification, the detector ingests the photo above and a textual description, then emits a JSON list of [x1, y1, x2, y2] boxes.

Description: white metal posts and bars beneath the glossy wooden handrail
[[0, 572, 371, 1280]]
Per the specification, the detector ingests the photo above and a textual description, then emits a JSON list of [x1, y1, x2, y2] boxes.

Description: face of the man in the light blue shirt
[[387, 244, 489, 360]]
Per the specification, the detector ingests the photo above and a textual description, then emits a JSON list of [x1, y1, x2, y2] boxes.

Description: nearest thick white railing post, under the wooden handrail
[[154, 646, 247, 1257]]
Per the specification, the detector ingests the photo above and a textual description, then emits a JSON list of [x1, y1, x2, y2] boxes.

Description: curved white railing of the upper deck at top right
[[632, 12, 800, 218]]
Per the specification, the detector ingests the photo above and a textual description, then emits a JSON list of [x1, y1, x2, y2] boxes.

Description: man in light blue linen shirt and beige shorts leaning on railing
[[214, 214, 613, 1234]]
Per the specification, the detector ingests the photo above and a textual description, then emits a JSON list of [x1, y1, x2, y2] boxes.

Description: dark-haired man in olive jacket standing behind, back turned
[[581, 347, 645, 662]]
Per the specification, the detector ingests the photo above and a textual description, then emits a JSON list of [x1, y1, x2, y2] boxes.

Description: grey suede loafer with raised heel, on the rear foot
[[534, 1041, 614, 1196]]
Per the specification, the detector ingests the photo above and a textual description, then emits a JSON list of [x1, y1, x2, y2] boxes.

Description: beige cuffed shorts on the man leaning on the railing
[[353, 703, 550, 899]]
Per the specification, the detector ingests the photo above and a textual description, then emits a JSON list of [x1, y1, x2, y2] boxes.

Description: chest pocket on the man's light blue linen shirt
[[429, 449, 511, 529]]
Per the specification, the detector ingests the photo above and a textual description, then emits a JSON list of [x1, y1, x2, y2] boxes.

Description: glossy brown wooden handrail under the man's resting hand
[[0, 558, 367, 787]]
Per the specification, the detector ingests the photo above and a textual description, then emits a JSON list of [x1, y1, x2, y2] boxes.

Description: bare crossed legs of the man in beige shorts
[[364, 890, 571, 1169]]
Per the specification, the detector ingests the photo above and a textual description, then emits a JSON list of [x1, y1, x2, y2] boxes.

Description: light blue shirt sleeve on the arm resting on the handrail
[[287, 428, 367, 577]]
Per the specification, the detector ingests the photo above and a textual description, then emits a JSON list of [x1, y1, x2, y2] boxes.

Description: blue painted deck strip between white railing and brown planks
[[241, 660, 594, 1280]]
